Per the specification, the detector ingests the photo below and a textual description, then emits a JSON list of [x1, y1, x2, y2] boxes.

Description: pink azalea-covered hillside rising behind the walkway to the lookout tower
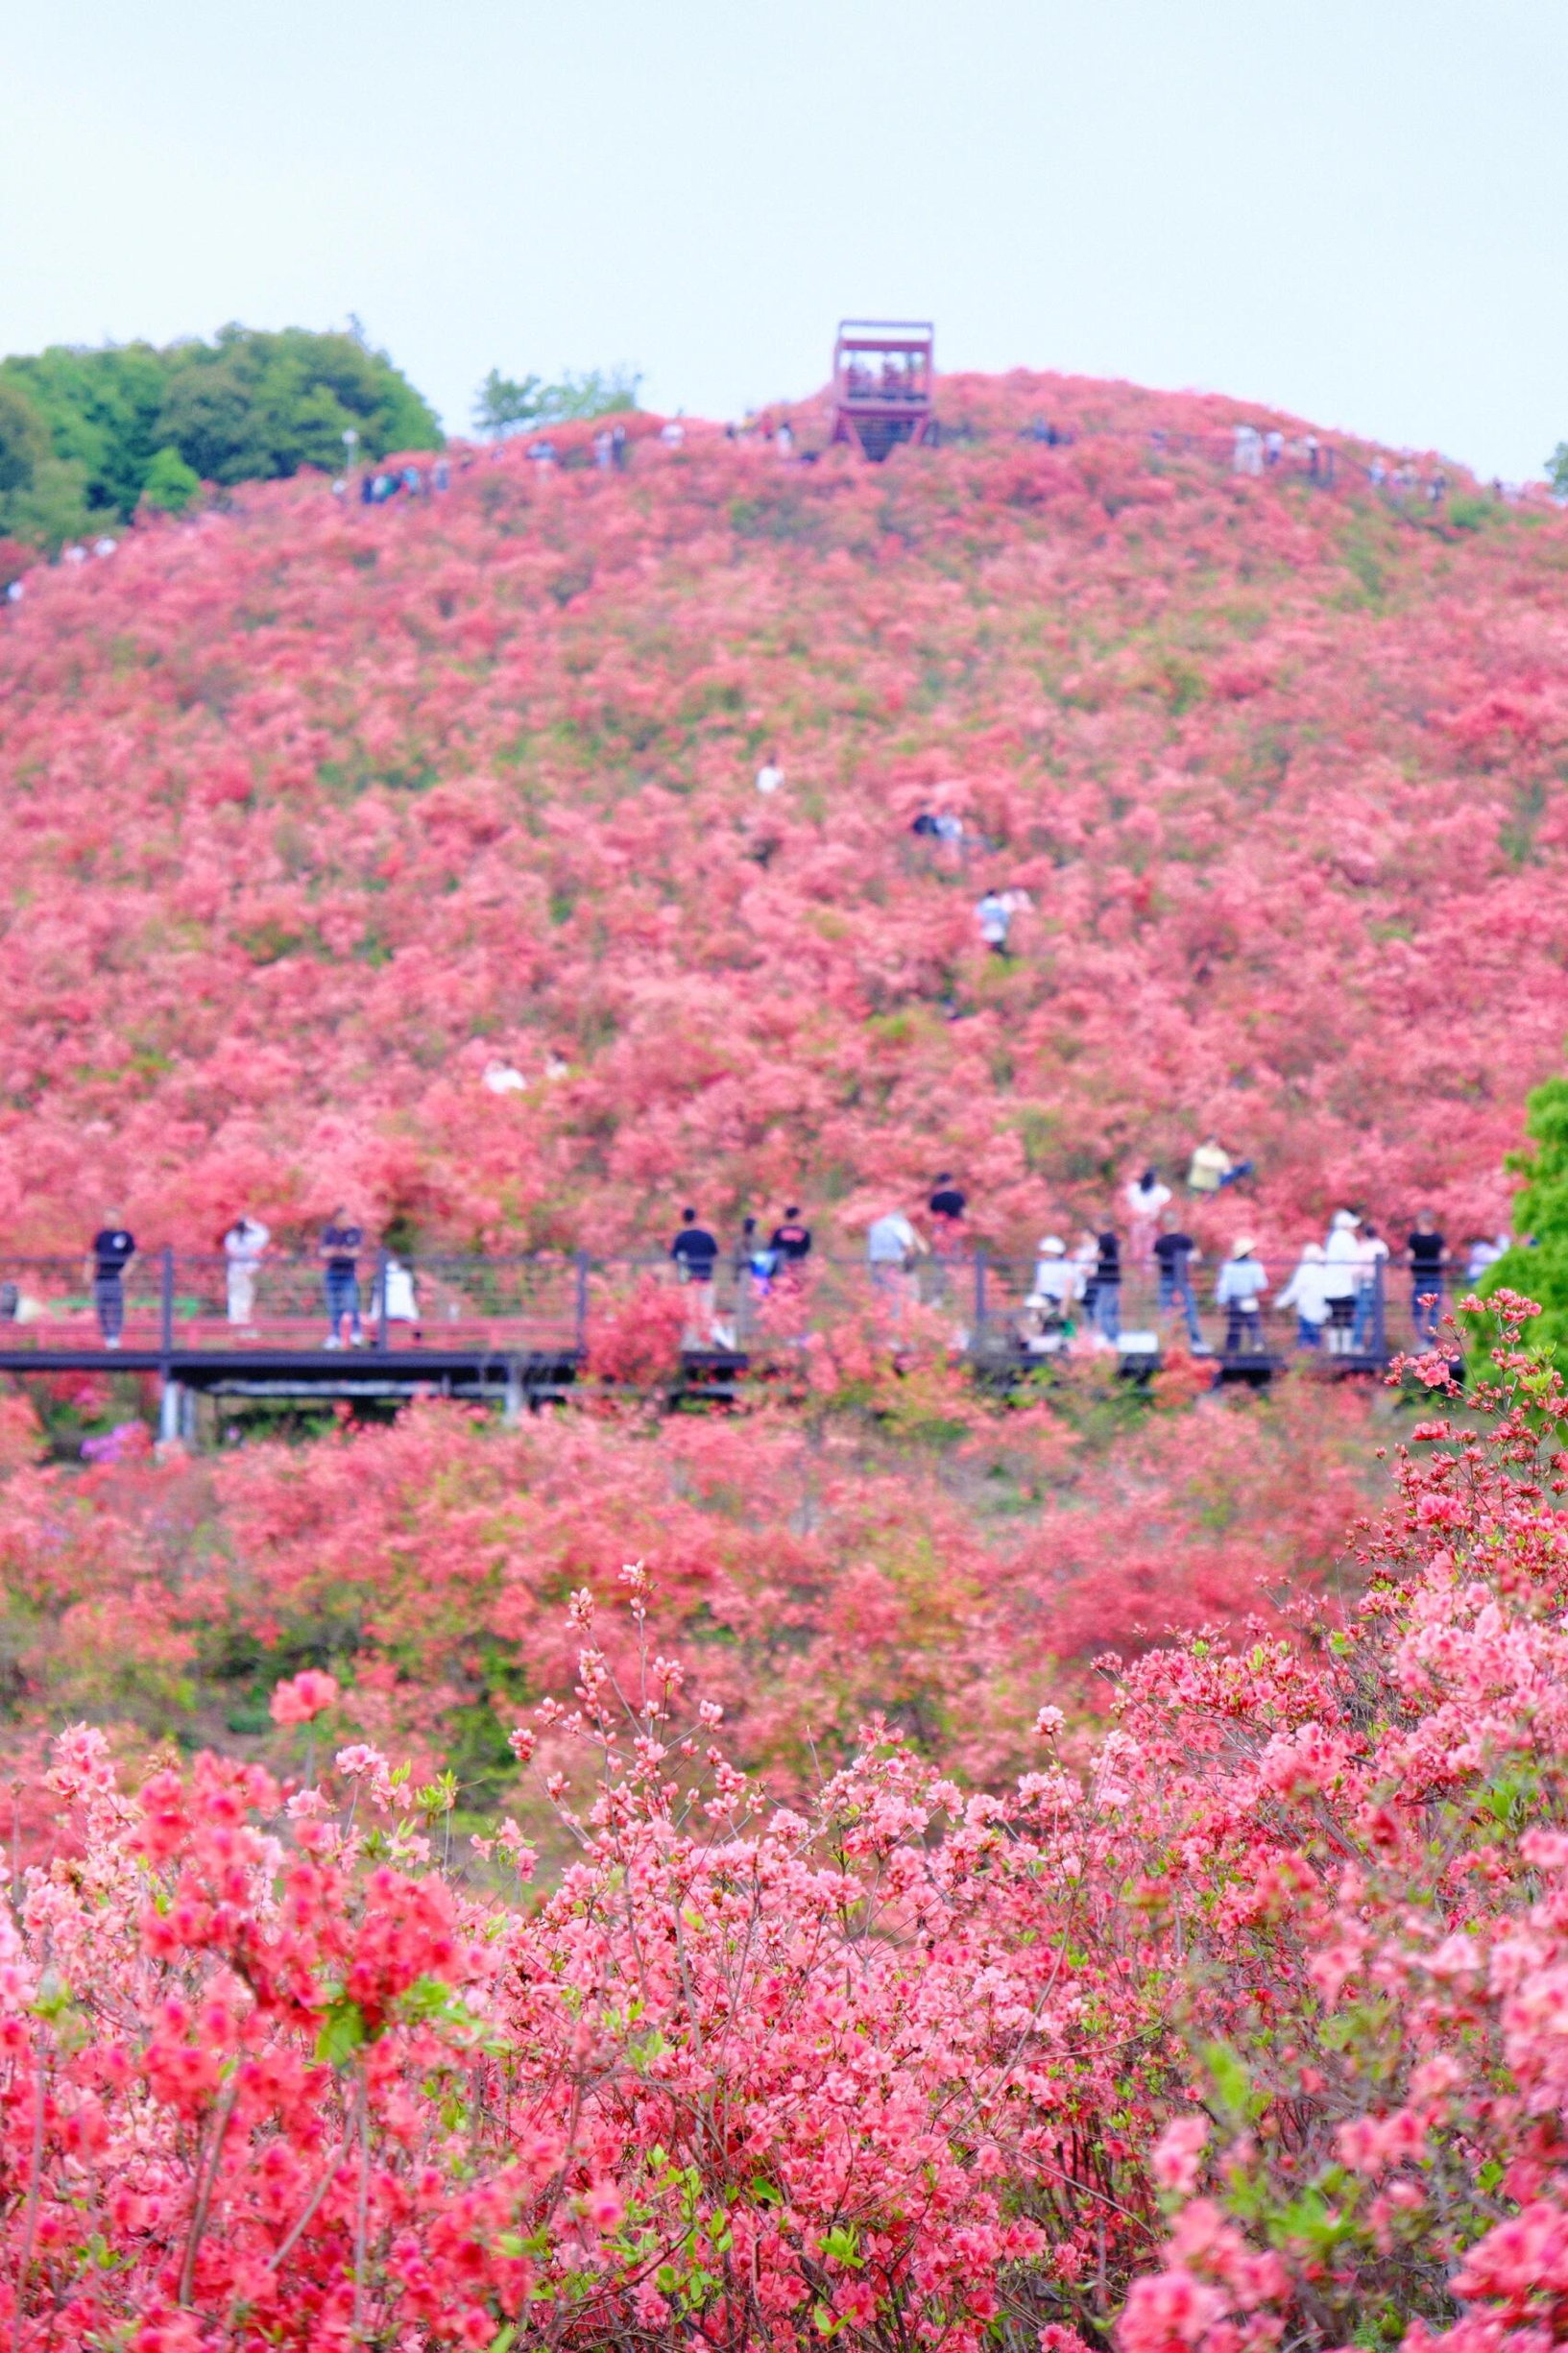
[[0, 362, 1568, 1248]]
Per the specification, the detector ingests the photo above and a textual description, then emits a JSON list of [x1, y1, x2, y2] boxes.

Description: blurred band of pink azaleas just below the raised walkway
[[0, 1373, 1378, 1788]]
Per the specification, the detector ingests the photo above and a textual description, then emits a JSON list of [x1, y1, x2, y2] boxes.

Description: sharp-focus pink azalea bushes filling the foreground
[[0, 1303, 1568, 2353]]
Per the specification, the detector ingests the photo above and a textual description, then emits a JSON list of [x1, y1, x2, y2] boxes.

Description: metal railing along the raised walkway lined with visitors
[[0, 1249, 1455, 1365]]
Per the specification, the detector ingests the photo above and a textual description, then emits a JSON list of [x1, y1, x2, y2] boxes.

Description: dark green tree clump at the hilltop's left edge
[[0, 327, 442, 548]]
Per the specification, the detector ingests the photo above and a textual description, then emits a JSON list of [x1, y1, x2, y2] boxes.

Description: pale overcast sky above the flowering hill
[[0, 0, 1568, 477]]
